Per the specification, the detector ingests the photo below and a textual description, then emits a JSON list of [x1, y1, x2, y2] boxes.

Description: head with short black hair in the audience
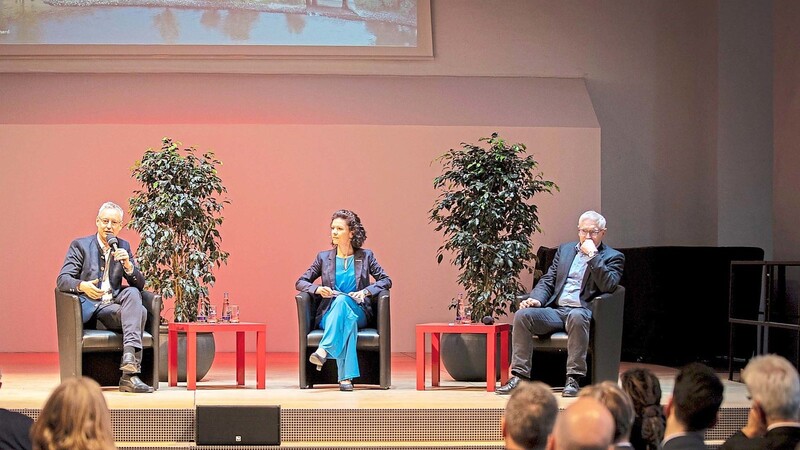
[[667, 363, 723, 431]]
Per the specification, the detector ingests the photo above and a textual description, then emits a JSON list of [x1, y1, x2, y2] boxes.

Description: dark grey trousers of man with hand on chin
[[511, 306, 592, 378]]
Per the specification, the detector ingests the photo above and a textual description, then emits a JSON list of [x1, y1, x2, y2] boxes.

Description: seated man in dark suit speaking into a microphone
[[56, 202, 153, 392]]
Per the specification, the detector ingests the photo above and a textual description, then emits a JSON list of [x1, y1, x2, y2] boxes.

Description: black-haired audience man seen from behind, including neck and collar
[[662, 363, 724, 450]]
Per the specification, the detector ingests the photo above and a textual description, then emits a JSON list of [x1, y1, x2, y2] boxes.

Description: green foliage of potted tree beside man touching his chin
[[429, 133, 558, 320]]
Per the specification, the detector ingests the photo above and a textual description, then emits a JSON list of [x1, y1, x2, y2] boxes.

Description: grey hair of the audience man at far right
[[742, 355, 800, 420]]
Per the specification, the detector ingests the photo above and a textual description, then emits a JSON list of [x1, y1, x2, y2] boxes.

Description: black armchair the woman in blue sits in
[[295, 290, 392, 389]]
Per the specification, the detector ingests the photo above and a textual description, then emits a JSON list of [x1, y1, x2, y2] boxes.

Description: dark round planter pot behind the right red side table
[[441, 333, 510, 381]]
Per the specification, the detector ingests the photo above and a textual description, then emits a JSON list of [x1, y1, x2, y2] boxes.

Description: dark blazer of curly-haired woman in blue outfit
[[294, 248, 392, 328]]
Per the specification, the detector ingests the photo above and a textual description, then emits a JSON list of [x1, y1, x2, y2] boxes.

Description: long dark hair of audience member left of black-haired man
[[620, 368, 666, 450]]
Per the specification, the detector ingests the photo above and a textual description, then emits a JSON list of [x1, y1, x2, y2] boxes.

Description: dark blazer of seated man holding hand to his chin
[[529, 241, 625, 309]]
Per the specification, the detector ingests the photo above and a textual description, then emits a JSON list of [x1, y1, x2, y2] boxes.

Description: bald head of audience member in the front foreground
[[547, 397, 614, 450]]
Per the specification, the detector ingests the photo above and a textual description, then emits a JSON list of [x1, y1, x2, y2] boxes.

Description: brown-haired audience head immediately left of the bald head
[[502, 382, 558, 450]]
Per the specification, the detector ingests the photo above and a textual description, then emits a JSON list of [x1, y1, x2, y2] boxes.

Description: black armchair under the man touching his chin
[[533, 285, 625, 385]]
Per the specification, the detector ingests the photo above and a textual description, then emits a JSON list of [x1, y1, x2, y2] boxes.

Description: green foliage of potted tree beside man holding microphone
[[129, 138, 230, 322]]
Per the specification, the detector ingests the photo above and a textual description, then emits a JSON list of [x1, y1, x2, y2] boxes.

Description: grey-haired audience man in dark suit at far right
[[720, 355, 800, 450]]
